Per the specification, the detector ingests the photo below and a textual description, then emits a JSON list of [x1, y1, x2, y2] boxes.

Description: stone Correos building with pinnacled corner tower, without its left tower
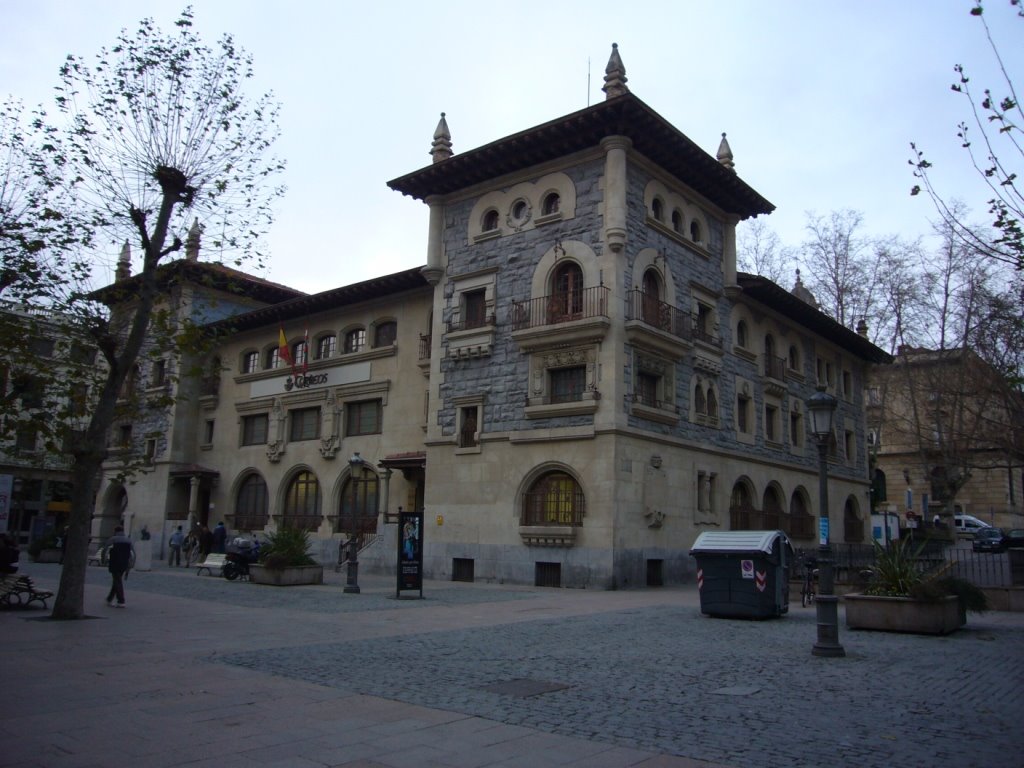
[[90, 49, 888, 588]]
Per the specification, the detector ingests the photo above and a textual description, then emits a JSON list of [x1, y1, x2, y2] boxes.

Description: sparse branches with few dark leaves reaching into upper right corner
[[909, 0, 1024, 269]]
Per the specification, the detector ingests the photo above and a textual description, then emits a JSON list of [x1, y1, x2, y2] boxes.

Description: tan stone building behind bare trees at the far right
[[867, 347, 1024, 528]]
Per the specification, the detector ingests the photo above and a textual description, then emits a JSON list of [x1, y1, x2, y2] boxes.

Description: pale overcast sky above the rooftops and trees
[[0, 0, 1024, 292]]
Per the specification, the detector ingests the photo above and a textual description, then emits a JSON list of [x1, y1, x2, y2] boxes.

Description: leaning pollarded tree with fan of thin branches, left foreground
[[14, 9, 283, 618]]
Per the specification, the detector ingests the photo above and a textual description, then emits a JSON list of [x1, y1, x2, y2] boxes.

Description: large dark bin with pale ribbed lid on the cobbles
[[690, 530, 794, 618]]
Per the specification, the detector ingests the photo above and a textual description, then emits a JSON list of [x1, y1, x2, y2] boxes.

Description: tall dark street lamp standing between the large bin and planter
[[807, 386, 846, 656]]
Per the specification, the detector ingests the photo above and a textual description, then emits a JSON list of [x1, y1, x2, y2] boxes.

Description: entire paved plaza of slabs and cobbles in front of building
[[0, 563, 1024, 768]]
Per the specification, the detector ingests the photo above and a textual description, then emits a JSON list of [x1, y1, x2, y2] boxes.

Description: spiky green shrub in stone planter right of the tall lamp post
[[844, 540, 988, 635]]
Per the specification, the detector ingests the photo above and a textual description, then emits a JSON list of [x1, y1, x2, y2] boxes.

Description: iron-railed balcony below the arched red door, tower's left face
[[512, 286, 610, 352]]
